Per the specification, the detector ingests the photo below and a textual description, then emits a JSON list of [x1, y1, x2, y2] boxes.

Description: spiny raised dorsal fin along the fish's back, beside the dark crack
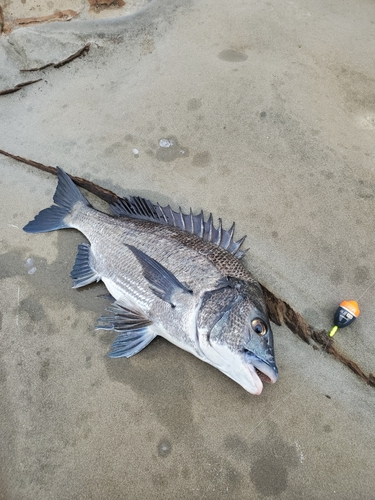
[[110, 196, 246, 259]]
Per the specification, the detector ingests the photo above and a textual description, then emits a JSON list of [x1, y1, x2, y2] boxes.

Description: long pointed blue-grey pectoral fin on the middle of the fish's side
[[126, 245, 193, 307]]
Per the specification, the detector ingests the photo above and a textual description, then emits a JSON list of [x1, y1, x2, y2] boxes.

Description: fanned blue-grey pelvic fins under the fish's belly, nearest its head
[[96, 302, 156, 358]]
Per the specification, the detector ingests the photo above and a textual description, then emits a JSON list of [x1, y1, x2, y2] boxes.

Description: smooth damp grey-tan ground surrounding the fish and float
[[0, 0, 375, 500]]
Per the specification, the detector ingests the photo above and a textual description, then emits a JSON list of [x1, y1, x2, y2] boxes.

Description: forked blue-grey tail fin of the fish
[[23, 167, 90, 233]]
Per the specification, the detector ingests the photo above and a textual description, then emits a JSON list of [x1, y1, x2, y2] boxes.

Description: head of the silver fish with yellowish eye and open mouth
[[198, 279, 278, 394]]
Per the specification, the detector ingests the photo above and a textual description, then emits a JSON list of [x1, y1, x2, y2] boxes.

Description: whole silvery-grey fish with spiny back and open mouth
[[23, 167, 278, 395]]
